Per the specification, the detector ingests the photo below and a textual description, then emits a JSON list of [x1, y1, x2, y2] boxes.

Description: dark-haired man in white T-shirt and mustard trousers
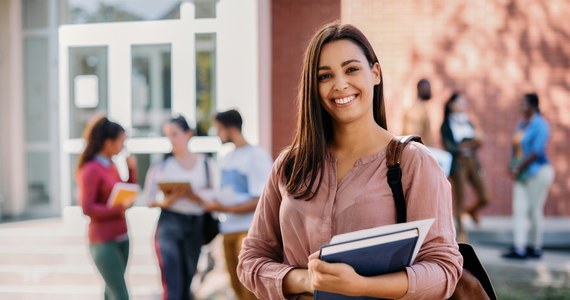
[[206, 109, 273, 300]]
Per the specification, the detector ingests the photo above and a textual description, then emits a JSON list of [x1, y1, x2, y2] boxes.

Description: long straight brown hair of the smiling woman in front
[[279, 22, 387, 200]]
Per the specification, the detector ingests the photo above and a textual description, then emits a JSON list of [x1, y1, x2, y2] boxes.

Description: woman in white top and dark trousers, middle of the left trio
[[144, 116, 211, 300]]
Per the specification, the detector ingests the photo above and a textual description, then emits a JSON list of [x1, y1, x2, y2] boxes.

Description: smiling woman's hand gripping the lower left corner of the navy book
[[309, 252, 363, 296]]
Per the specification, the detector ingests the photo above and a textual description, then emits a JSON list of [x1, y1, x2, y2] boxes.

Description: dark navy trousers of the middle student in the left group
[[155, 209, 202, 300]]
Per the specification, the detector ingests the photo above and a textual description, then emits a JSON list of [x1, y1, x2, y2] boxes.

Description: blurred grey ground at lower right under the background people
[[464, 217, 570, 300]]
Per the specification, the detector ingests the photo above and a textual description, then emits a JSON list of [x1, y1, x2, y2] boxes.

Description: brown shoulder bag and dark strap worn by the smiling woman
[[386, 136, 497, 300]]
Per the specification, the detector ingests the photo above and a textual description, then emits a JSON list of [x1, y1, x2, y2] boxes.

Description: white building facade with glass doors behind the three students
[[0, 0, 271, 218]]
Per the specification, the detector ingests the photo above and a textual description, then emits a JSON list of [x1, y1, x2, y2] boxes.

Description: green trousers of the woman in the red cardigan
[[89, 239, 129, 300]]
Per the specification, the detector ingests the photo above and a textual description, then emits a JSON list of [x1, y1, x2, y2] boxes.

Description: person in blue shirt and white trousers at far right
[[503, 93, 554, 259]]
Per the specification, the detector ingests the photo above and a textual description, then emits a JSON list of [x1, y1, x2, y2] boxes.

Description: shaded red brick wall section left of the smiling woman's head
[[271, 0, 340, 157]]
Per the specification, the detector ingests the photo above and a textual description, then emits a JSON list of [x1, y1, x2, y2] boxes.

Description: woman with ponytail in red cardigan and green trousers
[[77, 117, 136, 300]]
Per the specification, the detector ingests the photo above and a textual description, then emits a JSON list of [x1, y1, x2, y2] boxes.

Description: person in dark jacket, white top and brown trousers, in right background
[[441, 92, 489, 240]]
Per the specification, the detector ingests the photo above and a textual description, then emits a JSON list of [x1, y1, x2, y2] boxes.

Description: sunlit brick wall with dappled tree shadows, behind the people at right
[[342, 0, 570, 216]]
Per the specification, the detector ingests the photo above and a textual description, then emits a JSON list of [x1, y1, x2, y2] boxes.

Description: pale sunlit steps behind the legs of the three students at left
[[0, 208, 234, 300]]
